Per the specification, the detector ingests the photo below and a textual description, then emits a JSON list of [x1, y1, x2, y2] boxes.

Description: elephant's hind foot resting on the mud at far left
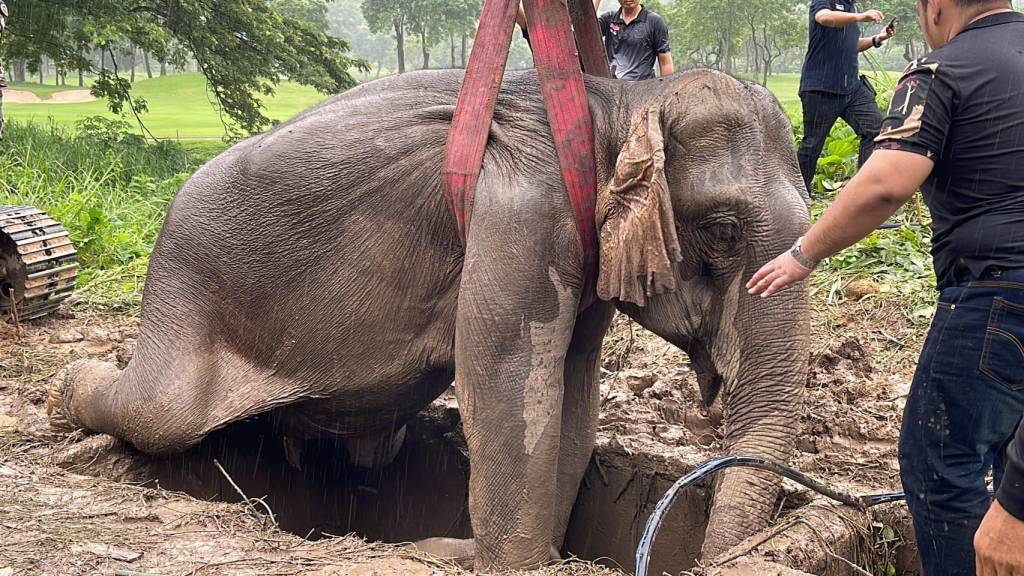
[[46, 360, 121, 433]]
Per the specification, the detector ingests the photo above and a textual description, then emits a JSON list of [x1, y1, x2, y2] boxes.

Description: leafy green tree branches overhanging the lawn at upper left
[[0, 0, 367, 132]]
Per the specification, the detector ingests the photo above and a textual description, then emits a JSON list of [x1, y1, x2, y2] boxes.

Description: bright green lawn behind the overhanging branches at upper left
[[4, 73, 326, 139]]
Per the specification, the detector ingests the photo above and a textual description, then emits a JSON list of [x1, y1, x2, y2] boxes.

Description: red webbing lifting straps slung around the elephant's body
[[442, 0, 607, 291]]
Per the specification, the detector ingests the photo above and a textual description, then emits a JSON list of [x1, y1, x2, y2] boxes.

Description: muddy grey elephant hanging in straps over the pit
[[47, 70, 809, 570]]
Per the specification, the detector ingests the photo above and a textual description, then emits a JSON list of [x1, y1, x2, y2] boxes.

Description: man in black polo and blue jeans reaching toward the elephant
[[748, 0, 1024, 576]]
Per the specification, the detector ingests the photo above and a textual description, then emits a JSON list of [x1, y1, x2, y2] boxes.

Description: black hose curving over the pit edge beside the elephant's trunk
[[636, 456, 905, 576]]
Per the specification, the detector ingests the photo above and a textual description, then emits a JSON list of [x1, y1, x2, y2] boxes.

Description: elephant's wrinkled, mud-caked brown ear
[[597, 108, 682, 306]]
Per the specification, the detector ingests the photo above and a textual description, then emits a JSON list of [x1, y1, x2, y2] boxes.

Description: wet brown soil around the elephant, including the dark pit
[[0, 293, 923, 574]]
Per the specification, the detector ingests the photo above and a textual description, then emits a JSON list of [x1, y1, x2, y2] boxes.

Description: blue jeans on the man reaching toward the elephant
[[899, 270, 1024, 576]]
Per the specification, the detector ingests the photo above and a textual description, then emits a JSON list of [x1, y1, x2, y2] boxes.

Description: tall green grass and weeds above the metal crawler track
[[0, 117, 216, 297]]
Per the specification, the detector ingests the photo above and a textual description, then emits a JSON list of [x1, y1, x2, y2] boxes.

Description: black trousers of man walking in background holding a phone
[[797, 80, 882, 192]]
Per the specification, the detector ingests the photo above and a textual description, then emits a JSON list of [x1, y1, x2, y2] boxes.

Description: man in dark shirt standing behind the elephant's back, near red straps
[[516, 0, 675, 80]]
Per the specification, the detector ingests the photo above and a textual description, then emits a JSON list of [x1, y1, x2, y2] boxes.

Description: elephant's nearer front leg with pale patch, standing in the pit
[[456, 204, 579, 570]]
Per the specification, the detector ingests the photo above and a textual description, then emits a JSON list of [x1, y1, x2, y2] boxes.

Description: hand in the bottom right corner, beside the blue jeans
[[974, 501, 1024, 576]]
